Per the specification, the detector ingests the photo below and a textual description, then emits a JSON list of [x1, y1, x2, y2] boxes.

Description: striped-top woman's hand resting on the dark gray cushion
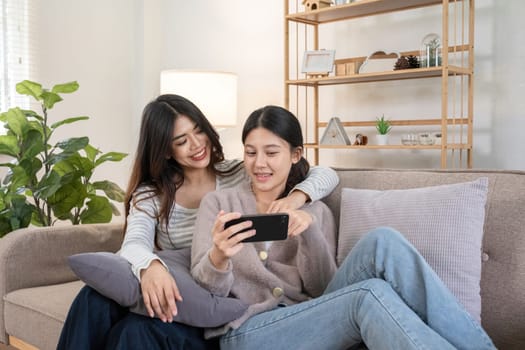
[[140, 260, 182, 322]]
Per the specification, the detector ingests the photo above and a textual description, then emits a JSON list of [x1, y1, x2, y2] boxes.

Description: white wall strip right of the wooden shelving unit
[[475, 0, 525, 169]]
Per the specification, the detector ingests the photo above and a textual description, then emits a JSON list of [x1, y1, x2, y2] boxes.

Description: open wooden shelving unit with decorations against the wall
[[284, 0, 474, 168]]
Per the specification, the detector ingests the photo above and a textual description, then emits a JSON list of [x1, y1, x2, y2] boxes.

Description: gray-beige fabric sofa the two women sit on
[[0, 169, 525, 350]]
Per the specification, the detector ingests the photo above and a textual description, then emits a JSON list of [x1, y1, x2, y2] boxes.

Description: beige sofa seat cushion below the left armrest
[[4, 281, 84, 349]]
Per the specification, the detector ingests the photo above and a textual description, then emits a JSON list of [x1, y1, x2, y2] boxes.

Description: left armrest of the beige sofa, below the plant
[[0, 223, 123, 342]]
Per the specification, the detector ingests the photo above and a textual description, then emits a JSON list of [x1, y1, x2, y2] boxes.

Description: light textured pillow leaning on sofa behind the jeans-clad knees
[[337, 178, 488, 321]]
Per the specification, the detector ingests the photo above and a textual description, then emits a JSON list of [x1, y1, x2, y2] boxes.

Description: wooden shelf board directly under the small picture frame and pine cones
[[286, 66, 471, 86]]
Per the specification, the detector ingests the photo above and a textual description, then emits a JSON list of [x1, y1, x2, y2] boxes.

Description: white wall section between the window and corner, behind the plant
[[31, 0, 137, 194]]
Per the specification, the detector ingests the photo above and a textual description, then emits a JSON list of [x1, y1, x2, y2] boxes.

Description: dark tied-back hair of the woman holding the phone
[[242, 106, 310, 198]]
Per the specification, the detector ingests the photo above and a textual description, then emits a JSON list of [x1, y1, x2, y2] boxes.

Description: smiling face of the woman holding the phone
[[244, 127, 301, 198]]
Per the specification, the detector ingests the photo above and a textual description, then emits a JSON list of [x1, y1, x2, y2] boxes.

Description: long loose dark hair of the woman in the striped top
[[124, 94, 238, 232]]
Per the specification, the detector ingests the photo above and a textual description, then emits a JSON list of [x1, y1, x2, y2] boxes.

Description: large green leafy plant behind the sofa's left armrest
[[0, 80, 127, 237]]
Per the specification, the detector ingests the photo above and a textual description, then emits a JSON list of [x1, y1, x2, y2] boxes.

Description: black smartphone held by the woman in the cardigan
[[224, 213, 288, 242]]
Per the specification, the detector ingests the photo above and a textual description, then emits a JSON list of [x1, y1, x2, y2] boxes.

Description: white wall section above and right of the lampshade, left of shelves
[[156, 0, 284, 158]]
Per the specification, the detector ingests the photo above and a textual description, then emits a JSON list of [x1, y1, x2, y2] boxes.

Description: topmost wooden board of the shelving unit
[[286, 0, 450, 24]]
